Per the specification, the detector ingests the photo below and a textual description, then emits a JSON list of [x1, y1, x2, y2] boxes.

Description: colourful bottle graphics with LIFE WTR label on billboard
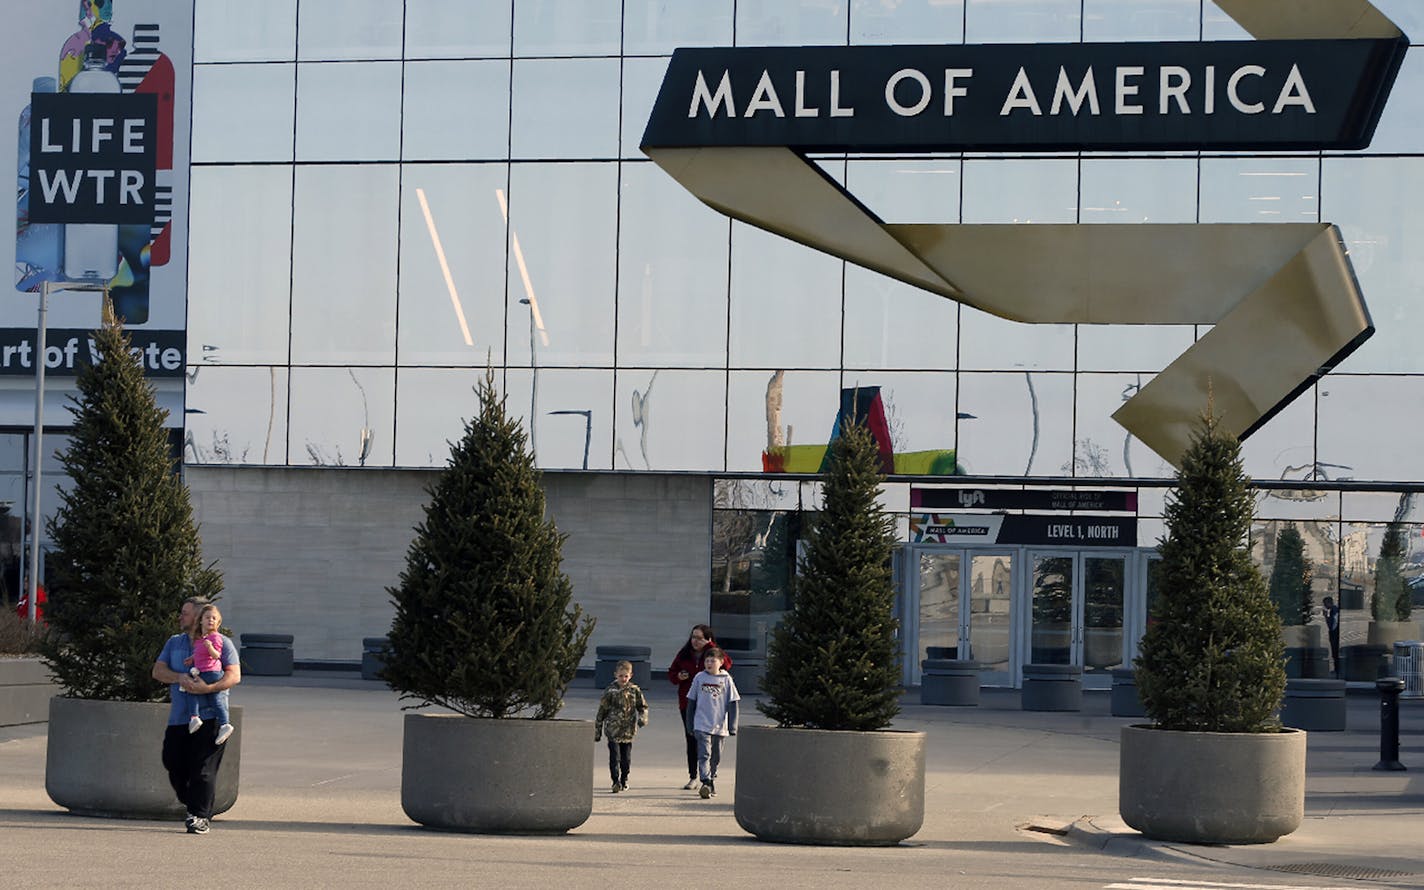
[[16, 0, 175, 325]]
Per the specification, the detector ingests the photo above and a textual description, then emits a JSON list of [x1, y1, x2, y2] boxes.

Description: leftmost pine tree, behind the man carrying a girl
[[44, 300, 222, 702]]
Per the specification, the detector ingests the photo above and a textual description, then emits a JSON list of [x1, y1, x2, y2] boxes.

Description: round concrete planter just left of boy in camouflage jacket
[[400, 713, 594, 834]]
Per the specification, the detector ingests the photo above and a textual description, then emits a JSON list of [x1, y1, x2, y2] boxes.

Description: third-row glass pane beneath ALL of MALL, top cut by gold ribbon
[[731, 222, 843, 367]]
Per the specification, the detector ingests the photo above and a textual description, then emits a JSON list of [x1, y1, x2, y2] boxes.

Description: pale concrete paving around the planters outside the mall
[[0, 672, 1424, 887]]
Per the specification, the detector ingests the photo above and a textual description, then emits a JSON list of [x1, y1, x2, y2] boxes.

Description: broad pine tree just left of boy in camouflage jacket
[[383, 372, 594, 719]]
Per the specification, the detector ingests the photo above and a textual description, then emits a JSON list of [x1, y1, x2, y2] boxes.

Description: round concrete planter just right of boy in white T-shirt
[[733, 726, 924, 846]]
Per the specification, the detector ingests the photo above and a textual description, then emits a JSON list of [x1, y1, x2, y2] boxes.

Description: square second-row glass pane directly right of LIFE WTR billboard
[[192, 64, 296, 164]]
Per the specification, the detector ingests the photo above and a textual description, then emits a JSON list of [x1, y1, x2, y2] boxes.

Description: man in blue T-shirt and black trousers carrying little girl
[[154, 597, 242, 834]]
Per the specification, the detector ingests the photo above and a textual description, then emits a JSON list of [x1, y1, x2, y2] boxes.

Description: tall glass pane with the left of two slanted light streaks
[[397, 164, 509, 367]]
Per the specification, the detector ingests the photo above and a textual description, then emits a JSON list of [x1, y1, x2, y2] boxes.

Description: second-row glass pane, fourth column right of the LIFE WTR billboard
[[510, 58, 618, 159]]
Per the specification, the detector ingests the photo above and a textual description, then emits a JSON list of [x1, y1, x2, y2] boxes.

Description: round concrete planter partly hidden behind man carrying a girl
[[44, 696, 242, 819]]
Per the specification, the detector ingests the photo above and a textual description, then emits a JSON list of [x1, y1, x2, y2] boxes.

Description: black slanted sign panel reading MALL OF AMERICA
[[642, 37, 1408, 151]]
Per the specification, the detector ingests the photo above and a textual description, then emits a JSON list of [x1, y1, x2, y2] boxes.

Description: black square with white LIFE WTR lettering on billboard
[[30, 93, 158, 225]]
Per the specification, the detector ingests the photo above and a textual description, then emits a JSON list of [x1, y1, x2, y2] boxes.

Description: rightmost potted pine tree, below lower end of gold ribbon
[[1135, 409, 1286, 732]]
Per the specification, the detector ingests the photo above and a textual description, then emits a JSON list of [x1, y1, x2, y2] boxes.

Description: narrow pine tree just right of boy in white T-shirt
[[758, 423, 900, 731]]
